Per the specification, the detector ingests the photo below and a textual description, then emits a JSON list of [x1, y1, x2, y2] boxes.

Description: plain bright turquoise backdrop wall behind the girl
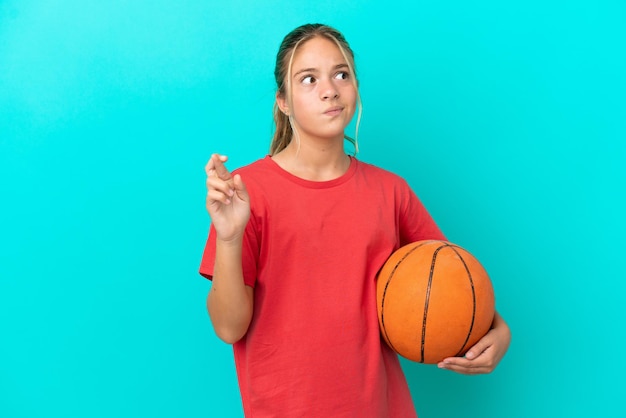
[[0, 0, 626, 418]]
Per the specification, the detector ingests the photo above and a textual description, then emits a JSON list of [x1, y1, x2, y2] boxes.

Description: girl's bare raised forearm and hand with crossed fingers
[[205, 154, 253, 344]]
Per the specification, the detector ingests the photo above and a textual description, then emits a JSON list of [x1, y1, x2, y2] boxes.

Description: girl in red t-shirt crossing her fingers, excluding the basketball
[[200, 24, 510, 418]]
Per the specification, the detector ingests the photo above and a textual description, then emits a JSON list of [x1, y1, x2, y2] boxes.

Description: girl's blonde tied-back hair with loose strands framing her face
[[270, 23, 362, 155]]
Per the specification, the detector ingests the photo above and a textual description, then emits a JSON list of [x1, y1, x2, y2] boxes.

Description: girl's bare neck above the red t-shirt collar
[[272, 140, 350, 181]]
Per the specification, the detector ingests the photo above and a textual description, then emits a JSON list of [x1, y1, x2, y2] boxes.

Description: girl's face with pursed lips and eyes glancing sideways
[[276, 37, 357, 147]]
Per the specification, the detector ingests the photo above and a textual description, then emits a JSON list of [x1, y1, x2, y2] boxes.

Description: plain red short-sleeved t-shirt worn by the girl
[[200, 156, 445, 418]]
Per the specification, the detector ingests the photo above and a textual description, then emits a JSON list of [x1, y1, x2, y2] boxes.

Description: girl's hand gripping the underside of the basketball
[[438, 312, 511, 374]]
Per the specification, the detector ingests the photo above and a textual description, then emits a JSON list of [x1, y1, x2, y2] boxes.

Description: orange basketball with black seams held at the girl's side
[[376, 241, 495, 364]]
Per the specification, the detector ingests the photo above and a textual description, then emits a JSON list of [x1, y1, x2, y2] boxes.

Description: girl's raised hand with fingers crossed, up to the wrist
[[205, 154, 250, 241]]
